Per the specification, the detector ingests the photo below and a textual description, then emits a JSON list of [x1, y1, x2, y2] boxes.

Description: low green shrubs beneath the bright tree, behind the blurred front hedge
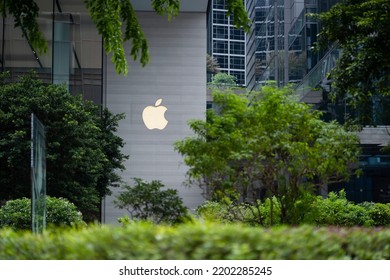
[[196, 191, 390, 227]]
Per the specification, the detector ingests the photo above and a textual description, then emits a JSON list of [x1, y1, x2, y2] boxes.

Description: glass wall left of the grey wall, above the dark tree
[[0, 0, 103, 105]]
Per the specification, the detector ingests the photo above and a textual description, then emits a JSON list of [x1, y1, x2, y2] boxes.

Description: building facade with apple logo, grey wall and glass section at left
[[0, 0, 210, 223]]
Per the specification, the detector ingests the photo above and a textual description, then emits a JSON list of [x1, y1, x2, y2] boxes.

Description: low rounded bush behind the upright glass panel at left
[[0, 196, 85, 230]]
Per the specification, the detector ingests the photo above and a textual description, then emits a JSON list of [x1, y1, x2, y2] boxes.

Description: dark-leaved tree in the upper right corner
[[317, 0, 390, 124]]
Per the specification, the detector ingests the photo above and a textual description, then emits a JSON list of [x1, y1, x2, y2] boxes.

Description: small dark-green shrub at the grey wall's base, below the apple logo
[[115, 178, 189, 224]]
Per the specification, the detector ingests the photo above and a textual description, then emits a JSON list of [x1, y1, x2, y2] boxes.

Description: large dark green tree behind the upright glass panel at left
[[0, 72, 127, 220]]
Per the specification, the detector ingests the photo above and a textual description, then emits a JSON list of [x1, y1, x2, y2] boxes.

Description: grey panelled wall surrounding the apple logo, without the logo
[[103, 12, 207, 223]]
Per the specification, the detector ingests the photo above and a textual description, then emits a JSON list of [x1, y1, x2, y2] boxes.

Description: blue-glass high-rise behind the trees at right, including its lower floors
[[256, 0, 390, 202]]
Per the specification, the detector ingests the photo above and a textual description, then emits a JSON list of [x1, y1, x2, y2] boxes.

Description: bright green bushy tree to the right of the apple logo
[[175, 86, 359, 222]]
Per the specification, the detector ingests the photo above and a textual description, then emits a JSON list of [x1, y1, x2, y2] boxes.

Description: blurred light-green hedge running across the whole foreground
[[0, 222, 390, 260]]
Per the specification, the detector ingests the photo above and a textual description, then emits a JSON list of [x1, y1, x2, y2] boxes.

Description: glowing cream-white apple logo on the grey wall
[[142, 98, 168, 130]]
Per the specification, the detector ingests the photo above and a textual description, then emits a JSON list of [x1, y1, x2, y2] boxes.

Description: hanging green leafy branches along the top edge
[[0, 0, 251, 74]]
